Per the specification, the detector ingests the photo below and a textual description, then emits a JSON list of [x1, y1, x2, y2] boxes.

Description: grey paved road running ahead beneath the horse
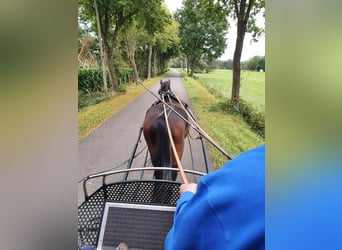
[[78, 71, 211, 203]]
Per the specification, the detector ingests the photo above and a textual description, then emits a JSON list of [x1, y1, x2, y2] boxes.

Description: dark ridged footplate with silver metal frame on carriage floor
[[97, 202, 175, 250]]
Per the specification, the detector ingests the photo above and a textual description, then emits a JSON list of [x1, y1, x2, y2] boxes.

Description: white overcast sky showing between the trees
[[164, 0, 265, 61]]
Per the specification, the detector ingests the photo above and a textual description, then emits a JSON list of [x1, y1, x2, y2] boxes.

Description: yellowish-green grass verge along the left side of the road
[[78, 75, 164, 140]]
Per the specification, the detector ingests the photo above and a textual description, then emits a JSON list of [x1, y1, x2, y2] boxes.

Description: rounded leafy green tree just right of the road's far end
[[175, 0, 228, 76]]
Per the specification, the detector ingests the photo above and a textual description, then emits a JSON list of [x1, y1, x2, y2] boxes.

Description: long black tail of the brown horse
[[151, 117, 172, 180]]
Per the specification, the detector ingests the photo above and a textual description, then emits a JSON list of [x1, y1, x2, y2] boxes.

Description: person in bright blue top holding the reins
[[164, 145, 265, 250]]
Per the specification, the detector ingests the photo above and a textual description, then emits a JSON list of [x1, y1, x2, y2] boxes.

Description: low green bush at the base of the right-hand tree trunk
[[213, 99, 265, 138]]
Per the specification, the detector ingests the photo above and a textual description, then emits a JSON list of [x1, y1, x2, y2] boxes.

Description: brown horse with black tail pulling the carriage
[[143, 79, 189, 181]]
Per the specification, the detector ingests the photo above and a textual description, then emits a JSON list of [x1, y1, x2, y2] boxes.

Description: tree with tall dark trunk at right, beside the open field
[[223, 0, 265, 105]]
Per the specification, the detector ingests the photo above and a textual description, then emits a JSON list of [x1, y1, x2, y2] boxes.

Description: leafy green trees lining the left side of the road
[[78, 0, 179, 90]]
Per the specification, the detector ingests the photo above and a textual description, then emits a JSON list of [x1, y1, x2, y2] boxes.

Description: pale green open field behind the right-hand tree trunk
[[195, 69, 265, 111]]
